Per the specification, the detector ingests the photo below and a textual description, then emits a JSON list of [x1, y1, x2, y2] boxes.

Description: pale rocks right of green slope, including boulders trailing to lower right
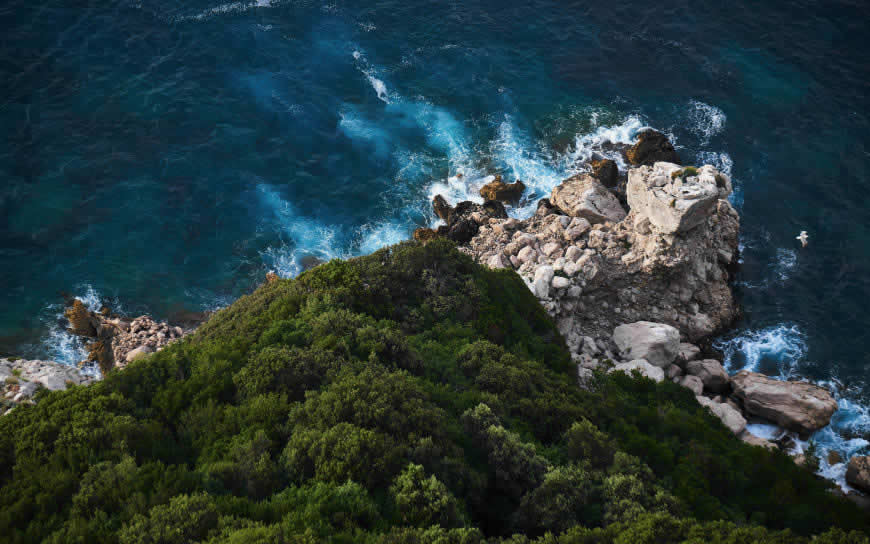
[[430, 134, 870, 496]]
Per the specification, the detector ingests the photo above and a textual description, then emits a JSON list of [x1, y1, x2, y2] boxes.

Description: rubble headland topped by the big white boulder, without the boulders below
[[463, 162, 739, 344]]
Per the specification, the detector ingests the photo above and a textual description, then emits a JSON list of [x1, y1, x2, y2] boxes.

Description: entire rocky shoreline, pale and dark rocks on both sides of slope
[[0, 131, 870, 498]]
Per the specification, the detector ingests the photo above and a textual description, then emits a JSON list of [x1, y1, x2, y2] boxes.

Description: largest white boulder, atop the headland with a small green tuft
[[626, 162, 731, 234]]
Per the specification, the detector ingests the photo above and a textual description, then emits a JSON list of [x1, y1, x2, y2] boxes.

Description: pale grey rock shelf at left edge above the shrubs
[[0, 359, 94, 415]]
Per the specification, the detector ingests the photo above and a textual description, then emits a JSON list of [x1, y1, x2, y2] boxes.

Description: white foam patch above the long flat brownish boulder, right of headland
[[714, 323, 807, 379]]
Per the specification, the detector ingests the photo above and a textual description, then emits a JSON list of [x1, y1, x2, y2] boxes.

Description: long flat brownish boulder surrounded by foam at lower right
[[731, 370, 837, 434]]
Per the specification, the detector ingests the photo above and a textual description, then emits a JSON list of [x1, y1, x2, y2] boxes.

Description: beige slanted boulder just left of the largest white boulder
[[550, 174, 625, 224]]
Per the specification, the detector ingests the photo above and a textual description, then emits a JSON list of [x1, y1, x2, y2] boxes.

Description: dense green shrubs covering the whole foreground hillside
[[0, 240, 868, 544]]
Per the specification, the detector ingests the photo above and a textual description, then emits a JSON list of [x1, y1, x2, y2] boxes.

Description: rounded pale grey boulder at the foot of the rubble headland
[[613, 321, 680, 368]]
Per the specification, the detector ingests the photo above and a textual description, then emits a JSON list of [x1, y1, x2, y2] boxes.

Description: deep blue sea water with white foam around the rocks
[[0, 0, 870, 484]]
